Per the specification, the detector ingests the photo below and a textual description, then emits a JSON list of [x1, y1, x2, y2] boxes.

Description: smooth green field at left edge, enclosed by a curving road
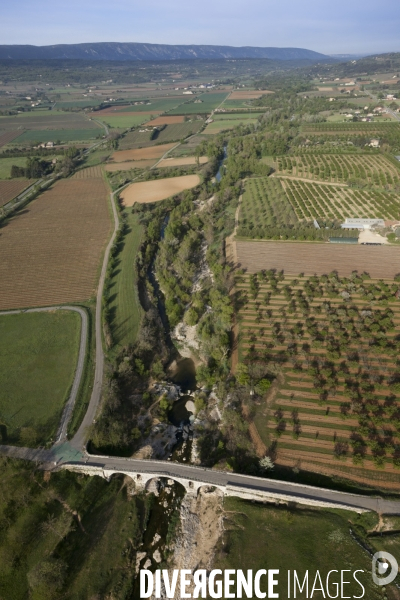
[[0, 311, 80, 446]]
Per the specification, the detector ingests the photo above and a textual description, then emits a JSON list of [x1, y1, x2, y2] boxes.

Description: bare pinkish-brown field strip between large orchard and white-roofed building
[[236, 241, 400, 279]]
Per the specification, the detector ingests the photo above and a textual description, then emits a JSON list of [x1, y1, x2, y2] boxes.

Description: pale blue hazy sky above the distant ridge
[[0, 0, 400, 54]]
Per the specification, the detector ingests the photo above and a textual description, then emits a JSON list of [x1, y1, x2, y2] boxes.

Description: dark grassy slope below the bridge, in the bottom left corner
[[0, 457, 151, 600]]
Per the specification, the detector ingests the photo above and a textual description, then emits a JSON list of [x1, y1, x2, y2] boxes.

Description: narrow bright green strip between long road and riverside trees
[[109, 211, 142, 349]]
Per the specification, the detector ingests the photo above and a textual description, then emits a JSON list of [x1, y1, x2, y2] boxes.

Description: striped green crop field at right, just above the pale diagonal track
[[276, 153, 400, 189]]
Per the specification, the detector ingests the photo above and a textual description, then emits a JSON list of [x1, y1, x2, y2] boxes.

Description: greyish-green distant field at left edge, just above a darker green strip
[[0, 111, 99, 132]]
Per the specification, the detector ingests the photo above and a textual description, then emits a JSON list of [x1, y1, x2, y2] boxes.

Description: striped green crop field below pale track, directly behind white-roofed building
[[281, 179, 400, 221]]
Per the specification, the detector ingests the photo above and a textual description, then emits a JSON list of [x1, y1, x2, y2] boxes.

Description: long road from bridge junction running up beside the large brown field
[[70, 190, 119, 450]]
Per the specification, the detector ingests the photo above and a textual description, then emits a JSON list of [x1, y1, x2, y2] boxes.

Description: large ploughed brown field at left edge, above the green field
[[0, 178, 110, 309]]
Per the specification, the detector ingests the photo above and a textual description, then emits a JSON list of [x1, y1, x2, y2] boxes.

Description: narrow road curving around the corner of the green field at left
[[0, 306, 88, 444]]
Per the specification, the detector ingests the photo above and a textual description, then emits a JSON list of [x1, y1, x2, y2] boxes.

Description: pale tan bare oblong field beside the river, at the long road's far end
[[121, 175, 200, 206]]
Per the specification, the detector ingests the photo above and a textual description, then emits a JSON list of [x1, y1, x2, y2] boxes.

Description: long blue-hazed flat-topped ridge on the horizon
[[0, 42, 336, 63]]
